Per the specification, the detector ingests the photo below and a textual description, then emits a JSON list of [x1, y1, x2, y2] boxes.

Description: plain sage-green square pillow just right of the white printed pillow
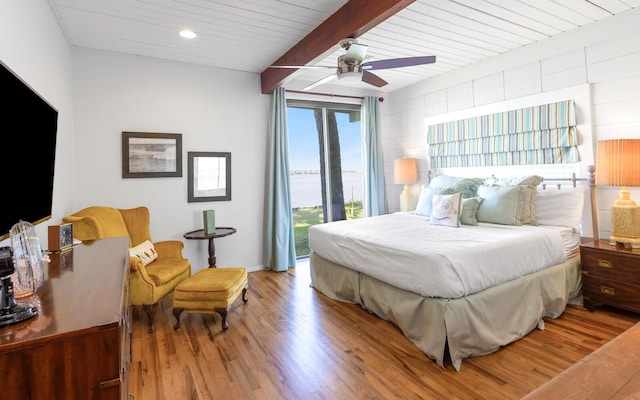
[[476, 185, 522, 225]]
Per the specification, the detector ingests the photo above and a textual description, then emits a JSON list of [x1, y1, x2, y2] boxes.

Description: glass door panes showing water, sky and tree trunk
[[287, 101, 363, 257]]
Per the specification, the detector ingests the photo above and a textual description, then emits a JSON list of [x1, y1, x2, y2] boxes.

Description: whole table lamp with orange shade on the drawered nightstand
[[596, 139, 640, 248]]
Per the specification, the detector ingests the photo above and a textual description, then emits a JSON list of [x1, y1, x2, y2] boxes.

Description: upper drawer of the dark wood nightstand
[[580, 249, 640, 284]]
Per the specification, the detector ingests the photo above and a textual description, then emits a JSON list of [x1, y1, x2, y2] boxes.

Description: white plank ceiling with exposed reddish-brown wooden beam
[[49, 0, 640, 93]]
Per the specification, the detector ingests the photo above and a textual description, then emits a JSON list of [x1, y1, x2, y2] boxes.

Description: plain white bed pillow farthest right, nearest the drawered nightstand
[[536, 186, 585, 228]]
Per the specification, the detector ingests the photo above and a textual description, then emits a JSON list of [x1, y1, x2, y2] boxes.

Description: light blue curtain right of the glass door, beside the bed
[[360, 96, 387, 217]]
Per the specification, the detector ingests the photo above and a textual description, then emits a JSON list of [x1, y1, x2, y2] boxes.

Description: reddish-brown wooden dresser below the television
[[0, 237, 131, 400]]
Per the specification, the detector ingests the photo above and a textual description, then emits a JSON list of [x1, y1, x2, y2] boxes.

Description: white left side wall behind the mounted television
[[0, 0, 75, 248]]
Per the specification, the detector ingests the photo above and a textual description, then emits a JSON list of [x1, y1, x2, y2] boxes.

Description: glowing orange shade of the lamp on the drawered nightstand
[[596, 139, 640, 186]]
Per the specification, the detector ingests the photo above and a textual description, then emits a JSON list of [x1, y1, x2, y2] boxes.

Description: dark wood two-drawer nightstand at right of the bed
[[580, 240, 640, 312]]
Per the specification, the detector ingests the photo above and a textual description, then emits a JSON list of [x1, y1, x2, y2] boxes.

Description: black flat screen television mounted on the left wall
[[0, 62, 58, 240]]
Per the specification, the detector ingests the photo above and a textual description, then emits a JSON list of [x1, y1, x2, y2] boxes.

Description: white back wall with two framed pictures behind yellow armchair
[[73, 50, 271, 271]]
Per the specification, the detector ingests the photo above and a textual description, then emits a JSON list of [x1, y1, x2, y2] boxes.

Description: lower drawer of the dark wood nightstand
[[582, 275, 640, 311]]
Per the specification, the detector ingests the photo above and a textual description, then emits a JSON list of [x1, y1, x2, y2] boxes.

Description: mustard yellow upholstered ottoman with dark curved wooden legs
[[173, 268, 249, 330]]
